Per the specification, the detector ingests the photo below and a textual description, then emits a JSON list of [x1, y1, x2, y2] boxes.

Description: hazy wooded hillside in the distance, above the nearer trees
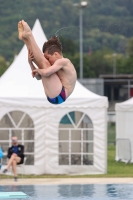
[[0, 0, 133, 61]]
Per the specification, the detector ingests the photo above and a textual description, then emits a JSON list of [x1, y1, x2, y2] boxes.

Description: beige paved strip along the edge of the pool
[[0, 178, 133, 185]]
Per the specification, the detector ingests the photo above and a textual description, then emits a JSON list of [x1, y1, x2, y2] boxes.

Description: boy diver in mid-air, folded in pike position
[[18, 20, 77, 104]]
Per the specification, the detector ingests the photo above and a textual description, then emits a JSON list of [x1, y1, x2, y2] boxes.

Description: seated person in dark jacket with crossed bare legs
[[3, 136, 24, 181]]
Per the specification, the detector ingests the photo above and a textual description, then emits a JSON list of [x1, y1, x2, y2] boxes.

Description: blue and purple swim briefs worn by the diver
[[47, 86, 66, 104]]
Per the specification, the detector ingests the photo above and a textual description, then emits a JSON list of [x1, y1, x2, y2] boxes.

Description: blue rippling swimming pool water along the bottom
[[0, 184, 133, 200]]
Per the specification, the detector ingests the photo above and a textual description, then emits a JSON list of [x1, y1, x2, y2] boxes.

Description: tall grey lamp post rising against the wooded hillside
[[74, 1, 88, 79]]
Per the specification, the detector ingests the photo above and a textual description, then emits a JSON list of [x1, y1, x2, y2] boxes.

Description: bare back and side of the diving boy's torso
[[56, 58, 77, 98]]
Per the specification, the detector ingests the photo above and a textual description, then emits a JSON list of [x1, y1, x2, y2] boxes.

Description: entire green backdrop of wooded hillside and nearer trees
[[0, 0, 133, 78]]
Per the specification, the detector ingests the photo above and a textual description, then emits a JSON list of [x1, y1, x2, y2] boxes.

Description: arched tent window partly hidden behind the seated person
[[0, 111, 34, 165]]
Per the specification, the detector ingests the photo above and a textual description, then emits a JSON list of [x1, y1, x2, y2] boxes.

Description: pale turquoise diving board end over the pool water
[[0, 192, 29, 199]]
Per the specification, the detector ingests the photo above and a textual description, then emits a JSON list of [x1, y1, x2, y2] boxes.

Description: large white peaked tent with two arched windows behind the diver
[[0, 20, 108, 174]]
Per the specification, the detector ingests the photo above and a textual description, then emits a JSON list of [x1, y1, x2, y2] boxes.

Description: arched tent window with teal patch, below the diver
[[59, 111, 93, 165]]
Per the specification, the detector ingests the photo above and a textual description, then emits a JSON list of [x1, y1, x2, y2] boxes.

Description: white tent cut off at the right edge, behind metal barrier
[[115, 98, 133, 162]]
